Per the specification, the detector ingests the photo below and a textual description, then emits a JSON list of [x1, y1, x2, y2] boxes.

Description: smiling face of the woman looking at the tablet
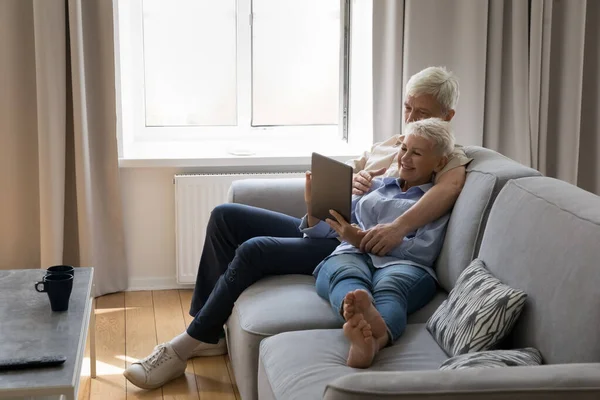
[[398, 135, 447, 186]]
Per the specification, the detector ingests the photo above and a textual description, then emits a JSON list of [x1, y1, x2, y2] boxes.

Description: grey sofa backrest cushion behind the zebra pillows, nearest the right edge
[[478, 178, 600, 364]]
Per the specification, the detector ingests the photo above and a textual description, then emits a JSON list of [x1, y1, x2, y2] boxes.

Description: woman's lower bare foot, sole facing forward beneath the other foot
[[344, 314, 379, 368]]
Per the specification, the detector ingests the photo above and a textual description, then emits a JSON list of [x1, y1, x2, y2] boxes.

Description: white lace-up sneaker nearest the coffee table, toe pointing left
[[123, 343, 187, 389]]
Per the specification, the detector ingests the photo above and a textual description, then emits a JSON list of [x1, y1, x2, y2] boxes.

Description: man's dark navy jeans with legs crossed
[[187, 204, 340, 343]]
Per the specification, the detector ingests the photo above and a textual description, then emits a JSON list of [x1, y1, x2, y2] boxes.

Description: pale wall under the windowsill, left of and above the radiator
[[120, 162, 308, 290]]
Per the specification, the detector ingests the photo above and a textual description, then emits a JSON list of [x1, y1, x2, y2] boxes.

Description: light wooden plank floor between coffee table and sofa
[[78, 290, 240, 400]]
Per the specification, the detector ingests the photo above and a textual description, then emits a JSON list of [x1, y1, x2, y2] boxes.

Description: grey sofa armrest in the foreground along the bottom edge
[[323, 363, 600, 400]]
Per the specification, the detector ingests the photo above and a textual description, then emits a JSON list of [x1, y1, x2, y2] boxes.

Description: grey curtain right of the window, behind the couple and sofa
[[373, 0, 600, 194]]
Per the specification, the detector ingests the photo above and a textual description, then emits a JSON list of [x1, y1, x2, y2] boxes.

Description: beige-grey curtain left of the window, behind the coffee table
[[0, 0, 127, 295]]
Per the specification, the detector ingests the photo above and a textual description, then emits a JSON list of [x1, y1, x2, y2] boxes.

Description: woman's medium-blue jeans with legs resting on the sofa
[[316, 253, 436, 342]]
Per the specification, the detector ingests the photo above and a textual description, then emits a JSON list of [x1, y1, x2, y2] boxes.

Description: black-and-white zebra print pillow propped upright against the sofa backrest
[[427, 259, 527, 357]]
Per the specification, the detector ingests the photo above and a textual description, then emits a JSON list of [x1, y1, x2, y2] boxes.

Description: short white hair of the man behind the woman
[[406, 67, 460, 113]]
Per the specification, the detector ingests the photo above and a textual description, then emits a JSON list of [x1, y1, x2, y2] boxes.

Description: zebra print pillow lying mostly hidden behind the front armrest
[[440, 347, 542, 369]]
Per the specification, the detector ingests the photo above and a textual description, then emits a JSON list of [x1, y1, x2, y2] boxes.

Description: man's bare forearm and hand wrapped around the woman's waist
[[360, 166, 466, 256]]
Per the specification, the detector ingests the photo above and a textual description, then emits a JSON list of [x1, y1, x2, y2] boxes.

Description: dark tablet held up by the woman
[[311, 153, 353, 222]]
